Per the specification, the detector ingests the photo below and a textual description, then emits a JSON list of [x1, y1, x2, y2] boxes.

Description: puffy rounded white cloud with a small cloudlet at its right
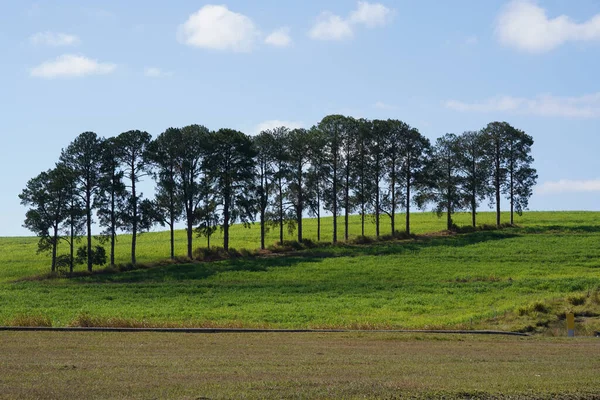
[[177, 5, 260, 52]]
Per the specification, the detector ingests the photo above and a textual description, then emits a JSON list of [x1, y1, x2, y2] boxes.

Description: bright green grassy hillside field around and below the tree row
[[0, 212, 600, 334]]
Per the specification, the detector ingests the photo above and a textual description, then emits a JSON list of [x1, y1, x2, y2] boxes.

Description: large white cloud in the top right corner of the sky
[[496, 0, 600, 53]]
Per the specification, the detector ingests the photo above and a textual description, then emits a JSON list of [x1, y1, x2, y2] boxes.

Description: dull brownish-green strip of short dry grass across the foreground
[[0, 332, 600, 399]]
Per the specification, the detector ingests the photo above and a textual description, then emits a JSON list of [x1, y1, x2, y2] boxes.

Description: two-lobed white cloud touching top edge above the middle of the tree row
[[308, 1, 393, 40]]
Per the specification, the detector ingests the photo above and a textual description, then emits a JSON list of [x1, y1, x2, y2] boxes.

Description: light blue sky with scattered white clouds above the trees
[[0, 0, 600, 236]]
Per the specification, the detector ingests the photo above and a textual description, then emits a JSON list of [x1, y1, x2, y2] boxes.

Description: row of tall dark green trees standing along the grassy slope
[[19, 115, 537, 272]]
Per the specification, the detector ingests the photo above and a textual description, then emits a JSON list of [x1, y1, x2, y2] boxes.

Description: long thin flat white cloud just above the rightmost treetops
[[445, 92, 600, 118]]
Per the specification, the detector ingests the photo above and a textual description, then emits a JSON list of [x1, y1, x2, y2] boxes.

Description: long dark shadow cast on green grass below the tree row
[[75, 231, 519, 284]]
